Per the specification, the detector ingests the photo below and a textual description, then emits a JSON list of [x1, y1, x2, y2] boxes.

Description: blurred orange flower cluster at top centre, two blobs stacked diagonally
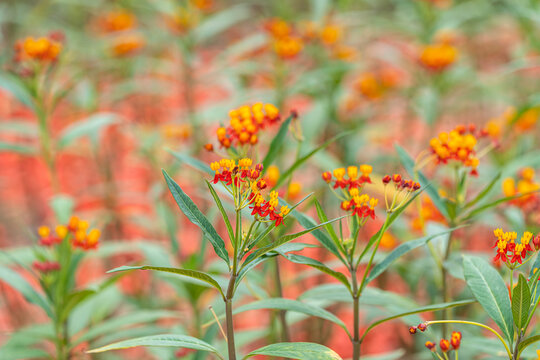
[[264, 18, 304, 59]]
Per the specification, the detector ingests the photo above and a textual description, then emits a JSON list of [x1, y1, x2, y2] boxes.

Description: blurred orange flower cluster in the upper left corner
[[15, 37, 62, 62]]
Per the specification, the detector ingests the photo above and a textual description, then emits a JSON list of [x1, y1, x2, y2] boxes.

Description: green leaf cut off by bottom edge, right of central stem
[[244, 342, 342, 360]]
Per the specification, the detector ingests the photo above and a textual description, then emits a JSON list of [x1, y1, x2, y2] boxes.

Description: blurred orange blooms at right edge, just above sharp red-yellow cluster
[[502, 167, 540, 211]]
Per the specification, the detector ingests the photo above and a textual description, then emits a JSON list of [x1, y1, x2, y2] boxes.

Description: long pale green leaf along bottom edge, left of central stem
[[88, 334, 222, 359]]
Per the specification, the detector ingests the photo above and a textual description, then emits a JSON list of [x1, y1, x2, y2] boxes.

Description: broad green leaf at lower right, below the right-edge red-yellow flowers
[[463, 256, 514, 342]]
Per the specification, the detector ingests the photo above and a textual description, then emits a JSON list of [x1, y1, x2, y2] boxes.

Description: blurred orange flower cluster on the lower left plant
[[38, 216, 101, 250]]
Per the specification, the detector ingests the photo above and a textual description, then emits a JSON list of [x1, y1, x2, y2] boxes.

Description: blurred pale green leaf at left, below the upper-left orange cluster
[[57, 112, 119, 149]]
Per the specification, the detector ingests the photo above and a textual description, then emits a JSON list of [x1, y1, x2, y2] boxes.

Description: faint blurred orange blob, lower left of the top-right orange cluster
[[355, 67, 401, 100]]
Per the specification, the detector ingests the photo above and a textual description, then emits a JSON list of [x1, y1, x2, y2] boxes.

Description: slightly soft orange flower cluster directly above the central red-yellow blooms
[[216, 103, 281, 149]]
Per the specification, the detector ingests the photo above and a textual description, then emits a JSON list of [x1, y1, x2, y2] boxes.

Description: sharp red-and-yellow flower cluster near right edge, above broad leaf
[[493, 229, 540, 269]]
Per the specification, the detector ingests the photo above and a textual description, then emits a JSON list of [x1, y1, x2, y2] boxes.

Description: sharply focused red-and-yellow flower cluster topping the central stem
[[210, 158, 290, 226]]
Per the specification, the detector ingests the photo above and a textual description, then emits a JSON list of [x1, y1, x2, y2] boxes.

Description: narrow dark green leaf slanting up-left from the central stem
[[163, 170, 229, 265]]
